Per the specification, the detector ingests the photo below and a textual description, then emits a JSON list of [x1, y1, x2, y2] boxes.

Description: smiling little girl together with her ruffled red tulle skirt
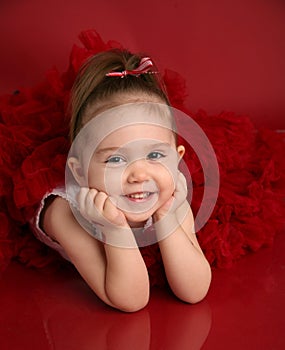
[[0, 30, 285, 311]]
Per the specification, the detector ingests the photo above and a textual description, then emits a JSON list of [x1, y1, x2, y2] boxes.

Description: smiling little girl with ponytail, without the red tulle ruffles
[[34, 49, 211, 312]]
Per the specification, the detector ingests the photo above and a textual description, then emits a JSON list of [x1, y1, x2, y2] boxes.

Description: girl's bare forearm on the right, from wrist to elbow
[[159, 226, 211, 303]]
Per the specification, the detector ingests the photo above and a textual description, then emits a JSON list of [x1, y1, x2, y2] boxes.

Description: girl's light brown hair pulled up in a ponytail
[[70, 49, 169, 141]]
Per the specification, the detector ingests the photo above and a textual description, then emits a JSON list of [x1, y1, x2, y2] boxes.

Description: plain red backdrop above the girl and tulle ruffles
[[0, 0, 285, 129]]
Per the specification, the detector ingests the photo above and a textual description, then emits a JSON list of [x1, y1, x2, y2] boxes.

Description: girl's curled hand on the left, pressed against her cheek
[[77, 187, 129, 229]]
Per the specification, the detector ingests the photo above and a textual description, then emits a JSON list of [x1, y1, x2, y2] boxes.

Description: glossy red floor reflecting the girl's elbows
[[0, 235, 285, 350]]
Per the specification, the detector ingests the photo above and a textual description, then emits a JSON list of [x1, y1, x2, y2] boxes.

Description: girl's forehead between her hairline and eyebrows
[[72, 103, 175, 155]]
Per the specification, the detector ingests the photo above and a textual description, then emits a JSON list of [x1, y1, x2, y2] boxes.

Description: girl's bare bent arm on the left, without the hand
[[42, 198, 149, 312]]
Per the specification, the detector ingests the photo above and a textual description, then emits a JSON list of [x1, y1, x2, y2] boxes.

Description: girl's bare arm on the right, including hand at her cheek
[[154, 173, 211, 303]]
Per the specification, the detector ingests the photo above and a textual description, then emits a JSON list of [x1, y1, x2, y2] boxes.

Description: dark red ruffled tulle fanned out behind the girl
[[0, 30, 285, 285]]
